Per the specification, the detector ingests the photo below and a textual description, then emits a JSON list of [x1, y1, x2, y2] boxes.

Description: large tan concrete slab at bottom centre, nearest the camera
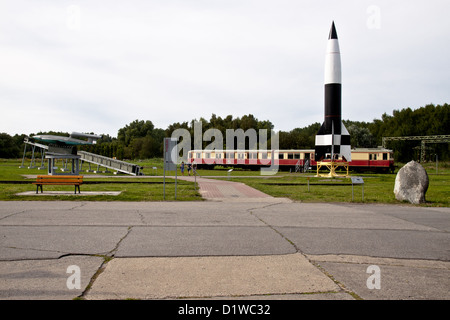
[[86, 253, 340, 300]]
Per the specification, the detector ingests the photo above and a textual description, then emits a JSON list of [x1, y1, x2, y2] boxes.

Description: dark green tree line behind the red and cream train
[[0, 104, 450, 162]]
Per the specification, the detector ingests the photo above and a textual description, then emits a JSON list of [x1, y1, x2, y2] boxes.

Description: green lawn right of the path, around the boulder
[[227, 164, 450, 207]]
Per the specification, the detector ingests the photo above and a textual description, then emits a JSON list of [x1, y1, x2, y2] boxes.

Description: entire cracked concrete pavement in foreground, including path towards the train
[[0, 177, 450, 300]]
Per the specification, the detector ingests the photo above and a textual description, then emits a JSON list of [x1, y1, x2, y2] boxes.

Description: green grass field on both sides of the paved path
[[0, 159, 450, 207]]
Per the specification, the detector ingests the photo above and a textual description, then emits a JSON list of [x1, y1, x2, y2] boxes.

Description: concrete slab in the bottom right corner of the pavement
[[307, 255, 450, 300]]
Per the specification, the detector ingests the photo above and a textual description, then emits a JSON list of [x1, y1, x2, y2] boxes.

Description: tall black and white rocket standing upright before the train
[[315, 21, 351, 161]]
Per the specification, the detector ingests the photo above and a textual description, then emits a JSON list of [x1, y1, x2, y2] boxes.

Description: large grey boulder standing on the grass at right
[[394, 161, 429, 204]]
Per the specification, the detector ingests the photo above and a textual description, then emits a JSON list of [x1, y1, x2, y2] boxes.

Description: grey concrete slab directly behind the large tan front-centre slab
[[116, 226, 296, 257]]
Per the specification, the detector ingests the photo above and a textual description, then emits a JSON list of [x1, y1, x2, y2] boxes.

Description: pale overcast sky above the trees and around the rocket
[[0, 0, 450, 136]]
